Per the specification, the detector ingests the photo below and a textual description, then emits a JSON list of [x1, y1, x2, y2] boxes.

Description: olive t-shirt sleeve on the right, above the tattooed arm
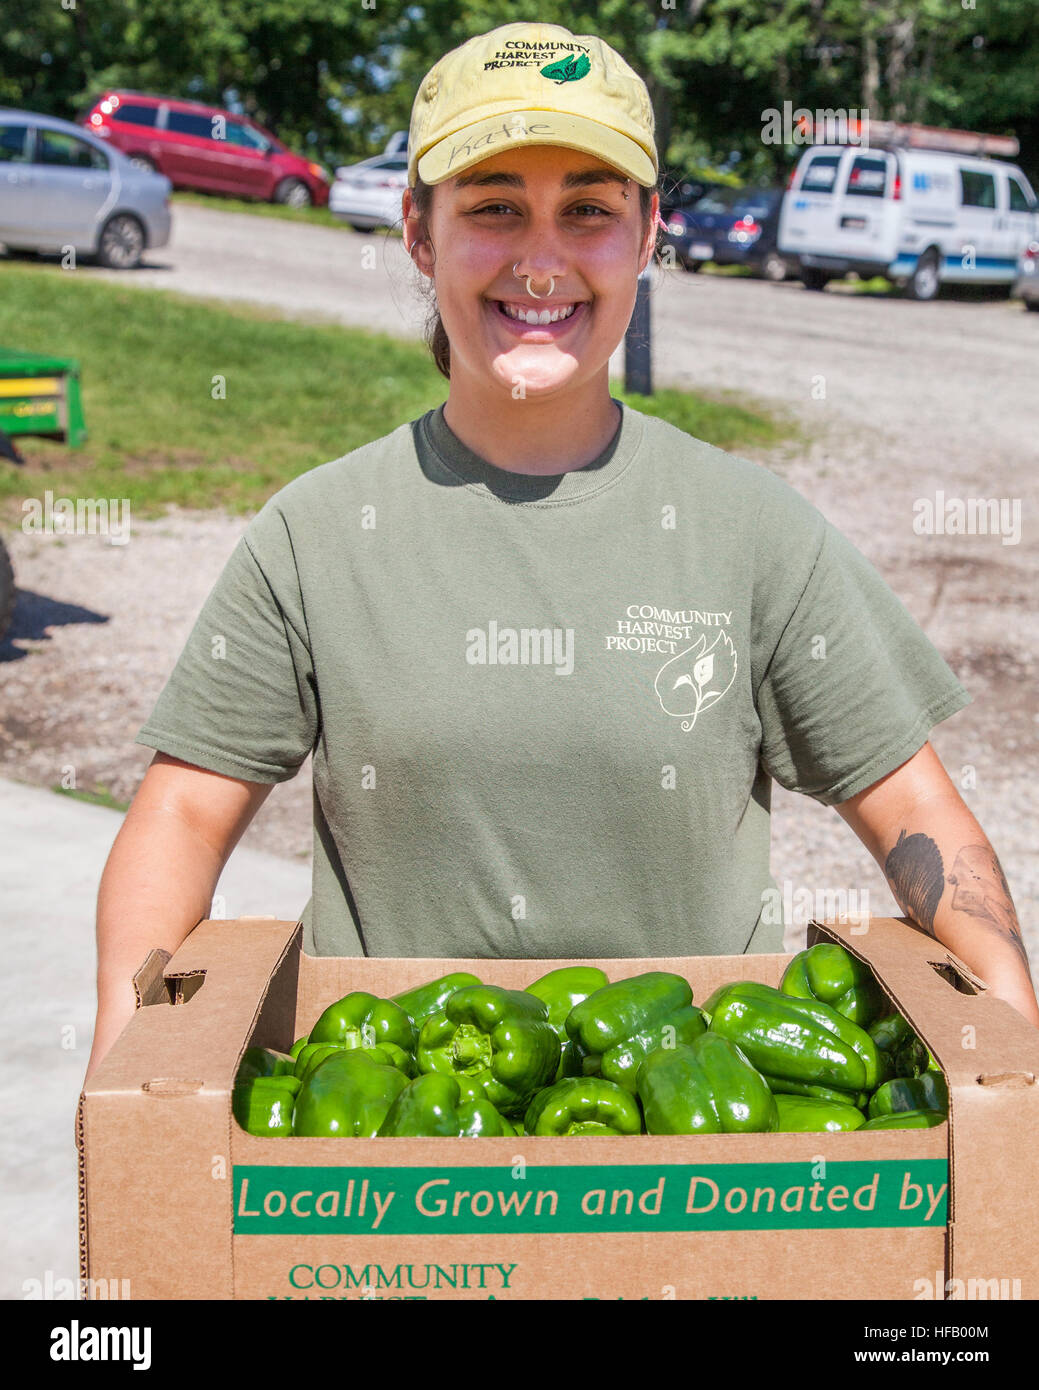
[[757, 514, 971, 805]]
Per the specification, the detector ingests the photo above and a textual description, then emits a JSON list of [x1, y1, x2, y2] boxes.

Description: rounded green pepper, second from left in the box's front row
[[292, 1048, 408, 1138]]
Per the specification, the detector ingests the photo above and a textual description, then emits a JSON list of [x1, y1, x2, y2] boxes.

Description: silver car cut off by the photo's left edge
[[0, 107, 172, 270]]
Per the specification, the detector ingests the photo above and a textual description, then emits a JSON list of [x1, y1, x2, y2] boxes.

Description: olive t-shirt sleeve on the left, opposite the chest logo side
[[135, 503, 320, 783]]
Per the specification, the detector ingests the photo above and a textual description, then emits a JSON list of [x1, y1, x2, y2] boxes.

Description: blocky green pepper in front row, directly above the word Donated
[[638, 1033, 779, 1134]]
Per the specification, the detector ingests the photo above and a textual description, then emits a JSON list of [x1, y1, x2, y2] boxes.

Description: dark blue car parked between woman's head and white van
[[665, 188, 794, 281]]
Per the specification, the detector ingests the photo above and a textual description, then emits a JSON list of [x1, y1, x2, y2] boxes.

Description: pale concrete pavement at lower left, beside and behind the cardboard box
[[0, 780, 310, 1298]]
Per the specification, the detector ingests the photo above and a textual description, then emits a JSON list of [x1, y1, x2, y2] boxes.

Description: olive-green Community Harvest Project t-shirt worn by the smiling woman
[[136, 406, 971, 958]]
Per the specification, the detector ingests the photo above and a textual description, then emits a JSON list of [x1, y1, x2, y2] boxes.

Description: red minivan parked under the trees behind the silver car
[[82, 92, 331, 207]]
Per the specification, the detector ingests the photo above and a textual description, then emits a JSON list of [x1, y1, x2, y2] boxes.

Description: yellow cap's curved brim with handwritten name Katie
[[417, 110, 657, 188]]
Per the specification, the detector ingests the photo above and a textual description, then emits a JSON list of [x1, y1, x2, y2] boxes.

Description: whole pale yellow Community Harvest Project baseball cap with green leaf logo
[[408, 24, 658, 188]]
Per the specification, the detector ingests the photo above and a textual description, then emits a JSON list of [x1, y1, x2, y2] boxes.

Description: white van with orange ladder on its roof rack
[[778, 126, 1039, 299]]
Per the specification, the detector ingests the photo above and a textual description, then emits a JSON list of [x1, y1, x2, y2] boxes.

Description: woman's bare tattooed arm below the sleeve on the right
[[836, 744, 1039, 1027]]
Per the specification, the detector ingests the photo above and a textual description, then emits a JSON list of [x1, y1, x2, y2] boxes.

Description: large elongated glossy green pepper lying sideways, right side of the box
[[704, 980, 887, 1094]]
